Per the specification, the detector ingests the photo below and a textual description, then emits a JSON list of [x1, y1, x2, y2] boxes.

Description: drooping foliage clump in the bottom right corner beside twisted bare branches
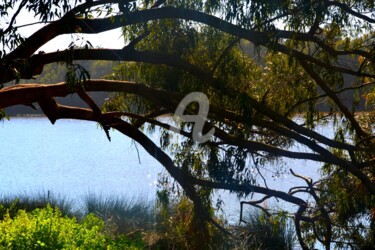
[[318, 165, 375, 249]]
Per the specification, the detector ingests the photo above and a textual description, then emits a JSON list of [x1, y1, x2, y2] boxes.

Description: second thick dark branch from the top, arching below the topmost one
[[1, 47, 370, 158]]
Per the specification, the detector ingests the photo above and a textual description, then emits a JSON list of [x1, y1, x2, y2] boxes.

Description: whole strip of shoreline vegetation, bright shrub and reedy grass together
[[0, 194, 296, 249]]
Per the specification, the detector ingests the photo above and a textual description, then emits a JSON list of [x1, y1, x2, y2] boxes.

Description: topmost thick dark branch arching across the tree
[[3, 6, 372, 81]]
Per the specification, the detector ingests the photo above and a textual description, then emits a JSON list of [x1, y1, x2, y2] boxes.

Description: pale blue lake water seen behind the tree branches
[[0, 118, 324, 221]]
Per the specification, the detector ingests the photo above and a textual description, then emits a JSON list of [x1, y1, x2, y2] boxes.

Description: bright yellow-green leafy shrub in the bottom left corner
[[0, 205, 143, 249]]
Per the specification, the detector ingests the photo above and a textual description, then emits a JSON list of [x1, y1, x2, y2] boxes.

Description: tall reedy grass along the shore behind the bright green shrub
[[0, 192, 296, 249]]
